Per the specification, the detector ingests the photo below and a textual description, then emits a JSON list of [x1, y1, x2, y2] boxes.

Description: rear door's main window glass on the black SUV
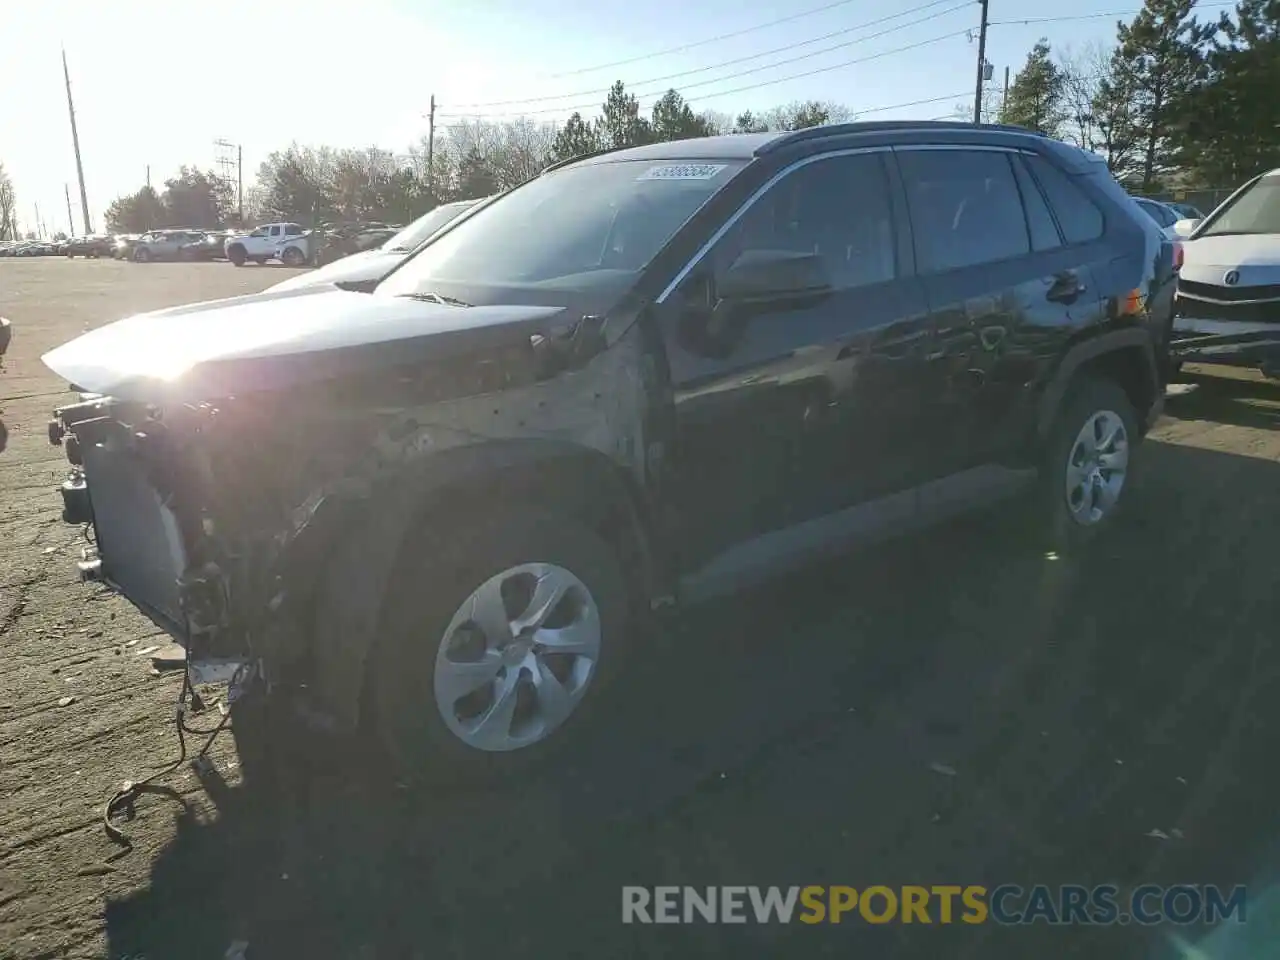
[[899, 150, 1030, 271]]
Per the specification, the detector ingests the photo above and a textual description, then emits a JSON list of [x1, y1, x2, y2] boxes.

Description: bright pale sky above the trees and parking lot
[[0, 0, 1219, 232]]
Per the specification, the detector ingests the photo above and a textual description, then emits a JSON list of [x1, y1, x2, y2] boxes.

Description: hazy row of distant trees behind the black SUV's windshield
[[106, 88, 851, 233]]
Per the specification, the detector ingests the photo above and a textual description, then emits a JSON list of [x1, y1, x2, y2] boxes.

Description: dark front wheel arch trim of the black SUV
[[296, 439, 660, 727]]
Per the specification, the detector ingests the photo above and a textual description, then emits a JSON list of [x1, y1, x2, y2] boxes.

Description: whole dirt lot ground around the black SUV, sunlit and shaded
[[0, 260, 1280, 960]]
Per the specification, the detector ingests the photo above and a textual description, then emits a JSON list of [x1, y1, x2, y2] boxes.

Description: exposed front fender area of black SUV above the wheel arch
[[205, 325, 662, 724]]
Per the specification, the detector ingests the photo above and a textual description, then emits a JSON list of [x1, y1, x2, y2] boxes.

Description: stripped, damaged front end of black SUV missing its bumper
[[46, 294, 645, 722]]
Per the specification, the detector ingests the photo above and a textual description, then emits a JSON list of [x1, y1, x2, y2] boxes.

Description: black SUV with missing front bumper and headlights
[[45, 123, 1172, 780]]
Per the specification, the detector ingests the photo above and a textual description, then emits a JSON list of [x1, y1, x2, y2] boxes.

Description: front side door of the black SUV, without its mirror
[[663, 150, 928, 570]]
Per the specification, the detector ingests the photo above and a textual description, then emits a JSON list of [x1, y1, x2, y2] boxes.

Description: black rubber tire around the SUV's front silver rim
[[366, 512, 631, 785]]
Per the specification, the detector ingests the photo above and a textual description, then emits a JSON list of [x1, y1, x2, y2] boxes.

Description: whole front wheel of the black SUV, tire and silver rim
[[370, 513, 630, 782]]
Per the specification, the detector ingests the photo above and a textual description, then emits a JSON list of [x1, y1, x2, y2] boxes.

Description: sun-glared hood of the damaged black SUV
[[42, 287, 566, 403]]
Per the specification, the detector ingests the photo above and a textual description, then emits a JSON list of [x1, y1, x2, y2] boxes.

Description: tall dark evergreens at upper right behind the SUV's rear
[[991, 0, 1280, 193]]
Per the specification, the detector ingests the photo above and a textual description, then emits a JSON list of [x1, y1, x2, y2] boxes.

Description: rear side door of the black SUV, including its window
[[896, 146, 1097, 479]]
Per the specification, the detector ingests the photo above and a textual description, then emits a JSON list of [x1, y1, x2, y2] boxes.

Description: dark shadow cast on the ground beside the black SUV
[[106, 443, 1280, 959]]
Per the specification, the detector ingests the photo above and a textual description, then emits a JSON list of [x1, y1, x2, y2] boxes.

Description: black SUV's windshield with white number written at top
[[379, 160, 744, 294]]
